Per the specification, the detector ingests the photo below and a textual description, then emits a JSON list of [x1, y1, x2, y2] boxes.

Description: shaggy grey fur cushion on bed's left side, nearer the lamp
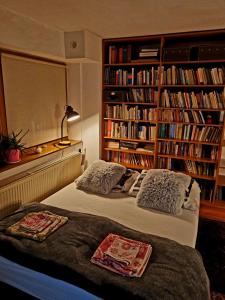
[[75, 160, 126, 194]]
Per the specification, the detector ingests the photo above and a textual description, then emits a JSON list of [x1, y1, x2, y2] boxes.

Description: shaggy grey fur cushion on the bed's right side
[[137, 169, 186, 215]]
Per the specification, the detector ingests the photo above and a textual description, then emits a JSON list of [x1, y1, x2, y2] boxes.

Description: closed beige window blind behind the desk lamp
[[1, 54, 67, 147]]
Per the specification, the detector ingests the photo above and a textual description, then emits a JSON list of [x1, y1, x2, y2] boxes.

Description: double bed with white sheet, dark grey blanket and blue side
[[0, 155, 209, 299]]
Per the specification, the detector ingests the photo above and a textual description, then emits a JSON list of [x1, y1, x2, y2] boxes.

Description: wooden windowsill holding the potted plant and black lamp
[[0, 139, 81, 173]]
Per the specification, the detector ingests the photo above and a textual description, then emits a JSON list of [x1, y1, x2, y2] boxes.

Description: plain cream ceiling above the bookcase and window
[[0, 0, 225, 38]]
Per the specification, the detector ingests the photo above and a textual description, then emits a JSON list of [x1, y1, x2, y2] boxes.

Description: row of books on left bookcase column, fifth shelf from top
[[105, 120, 156, 140]]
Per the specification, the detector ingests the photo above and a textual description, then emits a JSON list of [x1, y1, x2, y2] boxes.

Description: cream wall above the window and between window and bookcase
[[0, 7, 101, 171]]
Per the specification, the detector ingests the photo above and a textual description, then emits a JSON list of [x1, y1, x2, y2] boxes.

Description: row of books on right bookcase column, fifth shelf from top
[[159, 124, 222, 143]]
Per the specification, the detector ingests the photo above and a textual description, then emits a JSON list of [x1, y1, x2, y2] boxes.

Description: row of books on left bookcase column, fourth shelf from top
[[105, 104, 157, 121]]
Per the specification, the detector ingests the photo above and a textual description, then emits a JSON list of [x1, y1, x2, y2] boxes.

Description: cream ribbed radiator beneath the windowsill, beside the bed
[[0, 154, 81, 218]]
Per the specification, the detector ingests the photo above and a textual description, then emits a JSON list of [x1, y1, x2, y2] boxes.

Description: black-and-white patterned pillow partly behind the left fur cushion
[[112, 169, 140, 193]]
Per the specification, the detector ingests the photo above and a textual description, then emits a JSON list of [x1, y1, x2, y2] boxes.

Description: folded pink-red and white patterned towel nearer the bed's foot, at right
[[91, 233, 152, 277]]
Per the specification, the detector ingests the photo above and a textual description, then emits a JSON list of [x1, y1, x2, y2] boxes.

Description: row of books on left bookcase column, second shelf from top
[[104, 67, 159, 86]]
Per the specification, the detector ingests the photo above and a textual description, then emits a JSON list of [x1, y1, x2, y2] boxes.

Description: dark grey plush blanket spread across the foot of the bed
[[0, 203, 210, 300]]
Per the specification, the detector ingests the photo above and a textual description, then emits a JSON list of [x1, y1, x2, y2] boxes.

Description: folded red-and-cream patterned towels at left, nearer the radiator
[[6, 211, 68, 242]]
